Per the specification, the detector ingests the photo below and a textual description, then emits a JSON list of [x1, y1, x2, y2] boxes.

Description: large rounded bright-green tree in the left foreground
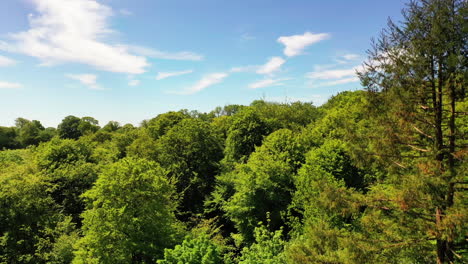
[[73, 158, 183, 263]]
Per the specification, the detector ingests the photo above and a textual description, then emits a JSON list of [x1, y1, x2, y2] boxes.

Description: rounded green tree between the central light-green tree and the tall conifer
[[294, 140, 363, 226]]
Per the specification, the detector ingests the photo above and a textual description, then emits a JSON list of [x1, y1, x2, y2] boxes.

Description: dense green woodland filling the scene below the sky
[[0, 0, 468, 264]]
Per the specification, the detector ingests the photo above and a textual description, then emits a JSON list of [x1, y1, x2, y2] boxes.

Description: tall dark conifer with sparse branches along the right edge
[[360, 0, 468, 263]]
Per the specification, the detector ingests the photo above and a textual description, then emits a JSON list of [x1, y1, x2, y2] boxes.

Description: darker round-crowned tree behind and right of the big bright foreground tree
[[156, 119, 223, 217]]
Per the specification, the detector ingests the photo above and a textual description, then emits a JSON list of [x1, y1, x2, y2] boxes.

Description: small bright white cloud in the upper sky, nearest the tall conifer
[[278, 32, 330, 57]]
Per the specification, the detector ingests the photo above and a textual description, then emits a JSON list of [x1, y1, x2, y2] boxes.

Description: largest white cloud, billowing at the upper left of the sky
[[0, 0, 148, 74]]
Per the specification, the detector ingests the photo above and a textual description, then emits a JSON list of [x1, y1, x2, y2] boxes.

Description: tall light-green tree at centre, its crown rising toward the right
[[222, 129, 304, 243]]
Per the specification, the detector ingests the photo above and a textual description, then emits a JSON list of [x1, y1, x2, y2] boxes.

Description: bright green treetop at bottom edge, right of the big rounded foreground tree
[[157, 235, 222, 264]]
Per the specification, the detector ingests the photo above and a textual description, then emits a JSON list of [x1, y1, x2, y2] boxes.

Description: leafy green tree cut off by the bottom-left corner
[[0, 151, 60, 263]]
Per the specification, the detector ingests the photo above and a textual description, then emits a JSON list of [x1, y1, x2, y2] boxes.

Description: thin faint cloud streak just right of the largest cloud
[[123, 46, 204, 61]]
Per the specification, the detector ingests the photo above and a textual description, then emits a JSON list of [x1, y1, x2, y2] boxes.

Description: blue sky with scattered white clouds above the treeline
[[0, 0, 407, 127]]
